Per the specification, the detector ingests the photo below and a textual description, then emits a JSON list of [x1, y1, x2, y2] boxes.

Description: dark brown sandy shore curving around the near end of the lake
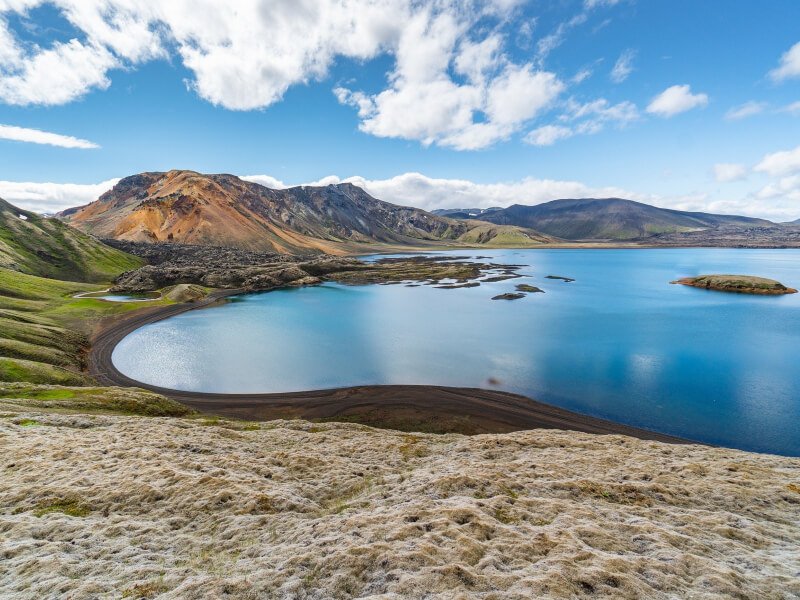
[[89, 290, 683, 442]]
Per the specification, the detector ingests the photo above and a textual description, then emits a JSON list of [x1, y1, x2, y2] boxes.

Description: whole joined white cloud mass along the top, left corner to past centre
[[0, 0, 586, 149]]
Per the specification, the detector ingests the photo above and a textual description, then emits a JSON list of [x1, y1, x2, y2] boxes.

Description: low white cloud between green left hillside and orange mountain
[[0, 179, 119, 212]]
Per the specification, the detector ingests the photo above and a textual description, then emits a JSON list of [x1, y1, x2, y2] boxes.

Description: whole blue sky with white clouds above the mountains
[[0, 0, 800, 220]]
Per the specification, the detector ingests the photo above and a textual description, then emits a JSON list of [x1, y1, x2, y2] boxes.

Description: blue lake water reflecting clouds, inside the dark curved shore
[[113, 249, 800, 455]]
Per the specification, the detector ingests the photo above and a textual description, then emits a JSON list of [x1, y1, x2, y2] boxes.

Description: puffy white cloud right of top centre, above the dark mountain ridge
[[334, 11, 565, 150]]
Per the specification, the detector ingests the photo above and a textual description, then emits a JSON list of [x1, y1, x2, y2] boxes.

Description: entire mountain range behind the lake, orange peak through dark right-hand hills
[[51, 170, 798, 254]]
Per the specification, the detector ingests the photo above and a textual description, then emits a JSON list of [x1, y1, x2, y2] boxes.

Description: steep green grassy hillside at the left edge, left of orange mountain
[[0, 199, 142, 282]]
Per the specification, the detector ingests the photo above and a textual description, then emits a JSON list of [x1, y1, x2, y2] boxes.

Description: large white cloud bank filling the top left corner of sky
[[0, 0, 406, 110]]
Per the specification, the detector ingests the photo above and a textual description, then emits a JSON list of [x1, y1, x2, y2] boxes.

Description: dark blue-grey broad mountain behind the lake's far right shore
[[450, 198, 774, 240]]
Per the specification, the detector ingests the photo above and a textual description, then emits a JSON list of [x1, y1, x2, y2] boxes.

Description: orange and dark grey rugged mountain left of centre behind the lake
[[59, 170, 556, 254]]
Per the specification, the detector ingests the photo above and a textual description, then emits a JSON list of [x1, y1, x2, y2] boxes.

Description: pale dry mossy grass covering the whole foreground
[[0, 413, 800, 599]]
